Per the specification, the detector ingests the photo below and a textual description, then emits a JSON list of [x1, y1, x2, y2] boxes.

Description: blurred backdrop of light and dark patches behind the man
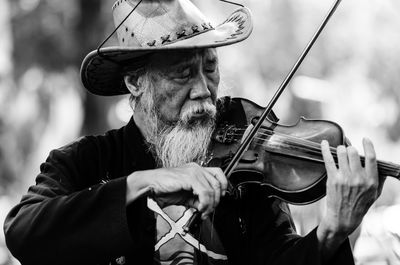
[[0, 0, 400, 265]]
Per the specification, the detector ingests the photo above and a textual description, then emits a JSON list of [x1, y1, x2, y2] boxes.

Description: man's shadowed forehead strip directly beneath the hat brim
[[150, 48, 218, 69]]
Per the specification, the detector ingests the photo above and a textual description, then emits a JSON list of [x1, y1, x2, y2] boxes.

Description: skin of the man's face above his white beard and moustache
[[145, 49, 220, 124]]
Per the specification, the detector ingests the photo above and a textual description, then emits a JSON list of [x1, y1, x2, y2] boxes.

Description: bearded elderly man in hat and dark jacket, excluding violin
[[5, 0, 381, 265]]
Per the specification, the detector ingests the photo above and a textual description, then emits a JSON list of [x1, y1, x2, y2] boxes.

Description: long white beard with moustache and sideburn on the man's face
[[138, 77, 216, 168]]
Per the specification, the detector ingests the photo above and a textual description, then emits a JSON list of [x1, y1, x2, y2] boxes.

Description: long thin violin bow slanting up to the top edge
[[224, 0, 341, 194]]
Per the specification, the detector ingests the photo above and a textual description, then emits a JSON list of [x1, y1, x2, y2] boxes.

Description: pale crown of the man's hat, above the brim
[[113, 0, 214, 47]]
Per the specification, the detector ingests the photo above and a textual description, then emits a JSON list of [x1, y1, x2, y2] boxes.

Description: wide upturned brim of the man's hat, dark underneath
[[81, 7, 253, 96]]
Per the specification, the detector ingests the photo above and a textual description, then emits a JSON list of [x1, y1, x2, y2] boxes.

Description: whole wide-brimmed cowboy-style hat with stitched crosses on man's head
[[81, 0, 253, 96]]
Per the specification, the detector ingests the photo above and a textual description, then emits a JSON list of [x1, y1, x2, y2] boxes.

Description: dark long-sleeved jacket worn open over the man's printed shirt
[[4, 98, 353, 265]]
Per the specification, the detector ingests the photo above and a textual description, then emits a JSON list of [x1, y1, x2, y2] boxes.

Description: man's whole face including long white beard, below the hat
[[131, 49, 219, 167]]
